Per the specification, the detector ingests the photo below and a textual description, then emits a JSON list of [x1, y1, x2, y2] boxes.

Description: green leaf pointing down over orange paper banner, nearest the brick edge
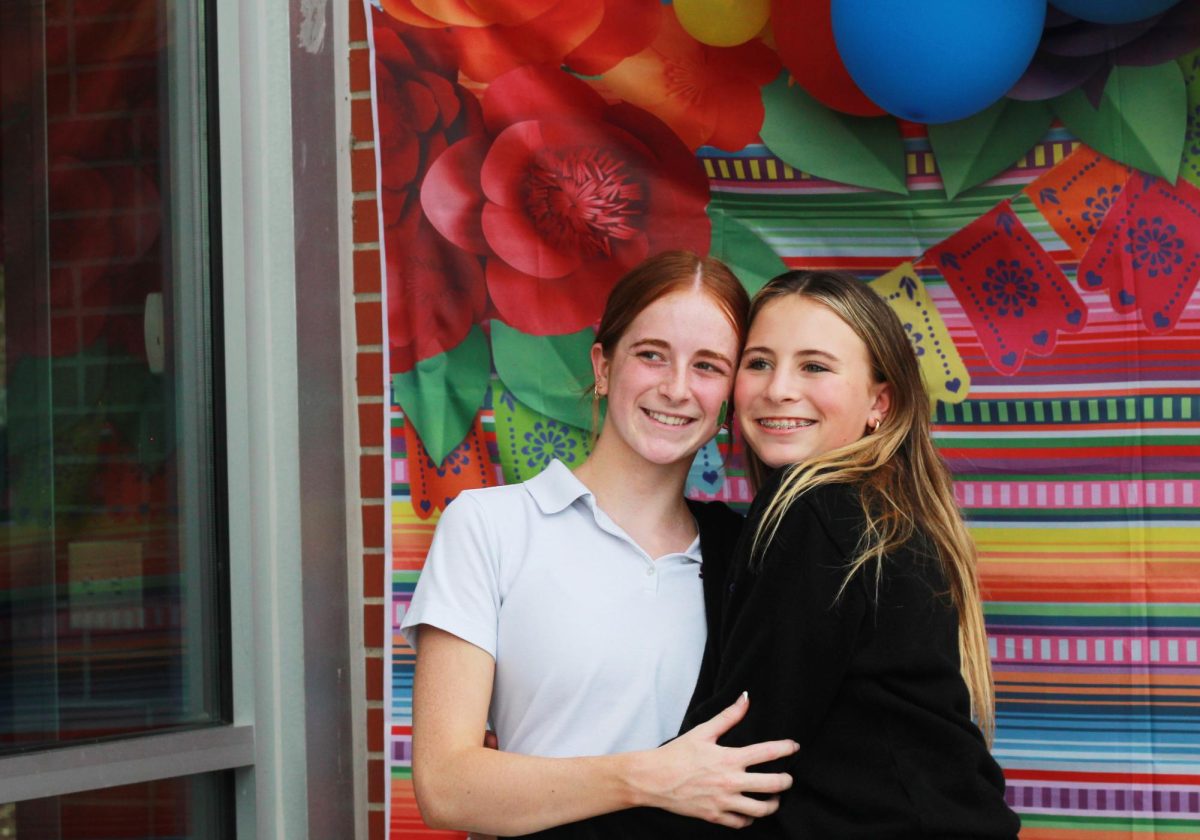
[[391, 326, 492, 464]]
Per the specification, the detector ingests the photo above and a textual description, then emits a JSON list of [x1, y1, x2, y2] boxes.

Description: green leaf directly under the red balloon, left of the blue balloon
[[761, 71, 908, 196]]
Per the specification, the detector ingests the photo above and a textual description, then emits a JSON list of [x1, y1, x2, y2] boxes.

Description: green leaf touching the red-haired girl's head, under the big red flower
[[492, 320, 595, 428]]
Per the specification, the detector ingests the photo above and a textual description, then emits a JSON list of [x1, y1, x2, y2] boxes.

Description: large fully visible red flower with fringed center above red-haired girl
[[421, 66, 710, 335]]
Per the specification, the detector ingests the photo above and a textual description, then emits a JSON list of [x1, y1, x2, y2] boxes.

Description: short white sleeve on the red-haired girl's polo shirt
[[400, 493, 500, 659]]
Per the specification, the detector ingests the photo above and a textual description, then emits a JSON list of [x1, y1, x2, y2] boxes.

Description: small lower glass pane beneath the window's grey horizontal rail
[[0, 774, 234, 840]]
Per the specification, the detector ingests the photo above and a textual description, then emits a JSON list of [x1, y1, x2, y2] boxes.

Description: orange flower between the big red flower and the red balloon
[[604, 8, 780, 151]]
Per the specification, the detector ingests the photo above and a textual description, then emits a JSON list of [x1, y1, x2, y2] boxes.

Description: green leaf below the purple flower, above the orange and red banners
[[1051, 61, 1188, 182]]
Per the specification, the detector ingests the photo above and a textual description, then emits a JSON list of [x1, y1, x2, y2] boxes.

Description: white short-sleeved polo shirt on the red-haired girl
[[401, 461, 706, 756]]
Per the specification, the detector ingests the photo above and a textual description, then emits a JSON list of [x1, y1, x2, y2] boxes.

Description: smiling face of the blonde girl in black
[[734, 294, 890, 468]]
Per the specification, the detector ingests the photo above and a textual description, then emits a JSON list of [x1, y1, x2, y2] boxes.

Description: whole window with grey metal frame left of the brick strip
[[0, 0, 366, 840]]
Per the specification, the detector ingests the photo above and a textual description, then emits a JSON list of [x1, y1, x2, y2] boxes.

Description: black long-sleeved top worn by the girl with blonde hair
[[520, 476, 1020, 840]]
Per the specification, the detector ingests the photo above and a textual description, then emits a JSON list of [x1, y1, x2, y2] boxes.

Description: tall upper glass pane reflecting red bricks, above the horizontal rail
[[0, 0, 223, 752]]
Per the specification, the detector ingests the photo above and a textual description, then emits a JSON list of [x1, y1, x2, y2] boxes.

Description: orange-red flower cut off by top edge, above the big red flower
[[383, 0, 662, 82]]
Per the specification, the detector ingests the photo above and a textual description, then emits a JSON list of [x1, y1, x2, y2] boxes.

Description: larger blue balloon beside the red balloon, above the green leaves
[[832, 0, 1046, 122]]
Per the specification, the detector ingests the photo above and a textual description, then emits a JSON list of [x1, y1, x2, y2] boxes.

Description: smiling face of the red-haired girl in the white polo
[[592, 290, 738, 464]]
